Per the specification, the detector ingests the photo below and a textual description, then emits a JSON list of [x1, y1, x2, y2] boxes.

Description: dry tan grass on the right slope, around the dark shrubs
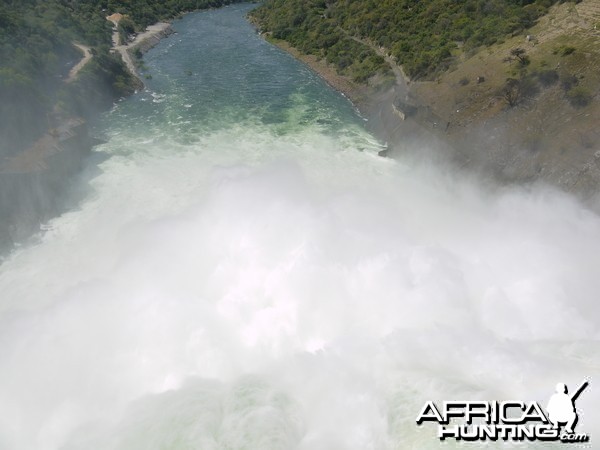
[[412, 0, 600, 189]]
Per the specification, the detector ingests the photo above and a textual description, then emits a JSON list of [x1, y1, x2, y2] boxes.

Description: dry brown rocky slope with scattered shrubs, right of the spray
[[411, 0, 600, 195]]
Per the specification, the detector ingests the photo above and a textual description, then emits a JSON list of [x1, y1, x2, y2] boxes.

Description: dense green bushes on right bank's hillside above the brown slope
[[251, 0, 580, 81]]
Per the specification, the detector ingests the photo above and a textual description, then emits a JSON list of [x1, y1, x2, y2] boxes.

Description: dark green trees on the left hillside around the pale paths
[[0, 0, 244, 159]]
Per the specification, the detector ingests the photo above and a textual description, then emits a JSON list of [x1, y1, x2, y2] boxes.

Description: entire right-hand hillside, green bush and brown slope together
[[253, 0, 600, 197]]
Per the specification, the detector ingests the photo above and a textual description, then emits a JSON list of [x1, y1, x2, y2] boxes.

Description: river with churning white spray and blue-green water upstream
[[0, 5, 600, 450]]
